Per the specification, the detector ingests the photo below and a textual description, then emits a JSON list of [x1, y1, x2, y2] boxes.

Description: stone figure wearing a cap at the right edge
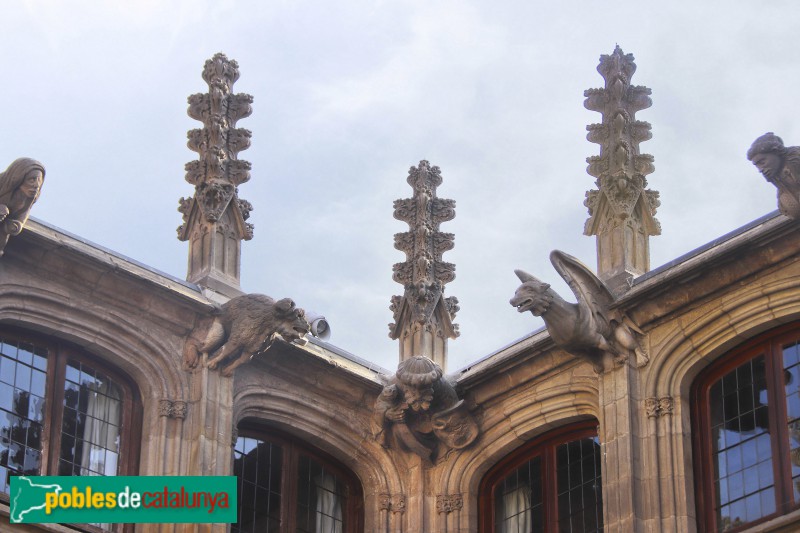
[[747, 132, 800, 220]]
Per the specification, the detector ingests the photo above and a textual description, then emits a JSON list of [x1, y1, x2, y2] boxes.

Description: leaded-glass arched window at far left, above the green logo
[[0, 328, 141, 529]]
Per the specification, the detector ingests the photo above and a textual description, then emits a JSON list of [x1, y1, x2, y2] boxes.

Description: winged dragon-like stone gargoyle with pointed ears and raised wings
[[509, 250, 648, 372]]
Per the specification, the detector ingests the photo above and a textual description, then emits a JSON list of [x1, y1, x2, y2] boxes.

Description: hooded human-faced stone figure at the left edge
[[0, 157, 44, 256]]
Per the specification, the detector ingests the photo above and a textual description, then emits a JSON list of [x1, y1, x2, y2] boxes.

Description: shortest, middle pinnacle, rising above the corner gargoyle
[[389, 161, 458, 368]]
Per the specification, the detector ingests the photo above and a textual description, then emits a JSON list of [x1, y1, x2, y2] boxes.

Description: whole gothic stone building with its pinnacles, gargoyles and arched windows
[[0, 48, 800, 533]]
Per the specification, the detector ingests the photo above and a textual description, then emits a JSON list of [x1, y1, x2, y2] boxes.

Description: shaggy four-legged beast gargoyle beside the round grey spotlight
[[183, 294, 311, 376]]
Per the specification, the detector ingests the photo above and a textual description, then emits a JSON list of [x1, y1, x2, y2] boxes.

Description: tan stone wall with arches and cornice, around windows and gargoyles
[[0, 213, 800, 533]]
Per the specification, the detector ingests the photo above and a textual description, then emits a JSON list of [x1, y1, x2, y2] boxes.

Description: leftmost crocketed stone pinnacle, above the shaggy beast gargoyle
[[178, 54, 253, 296]]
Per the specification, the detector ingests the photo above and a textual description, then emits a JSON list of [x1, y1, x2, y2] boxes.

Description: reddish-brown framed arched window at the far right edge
[[692, 323, 800, 532]]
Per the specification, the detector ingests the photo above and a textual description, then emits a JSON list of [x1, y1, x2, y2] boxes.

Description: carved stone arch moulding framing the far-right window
[[642, 276, 800, 529]]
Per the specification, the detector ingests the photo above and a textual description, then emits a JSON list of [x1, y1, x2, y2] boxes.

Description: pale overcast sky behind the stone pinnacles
[[0, 0, 800, 371]]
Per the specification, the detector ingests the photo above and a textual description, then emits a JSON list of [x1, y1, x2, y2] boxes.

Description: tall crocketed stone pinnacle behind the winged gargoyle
[[584, 45, 661, 290]]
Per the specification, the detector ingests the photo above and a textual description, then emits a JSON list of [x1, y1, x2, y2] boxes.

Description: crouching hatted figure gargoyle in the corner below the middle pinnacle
[[374, 355, 478, 461]]
